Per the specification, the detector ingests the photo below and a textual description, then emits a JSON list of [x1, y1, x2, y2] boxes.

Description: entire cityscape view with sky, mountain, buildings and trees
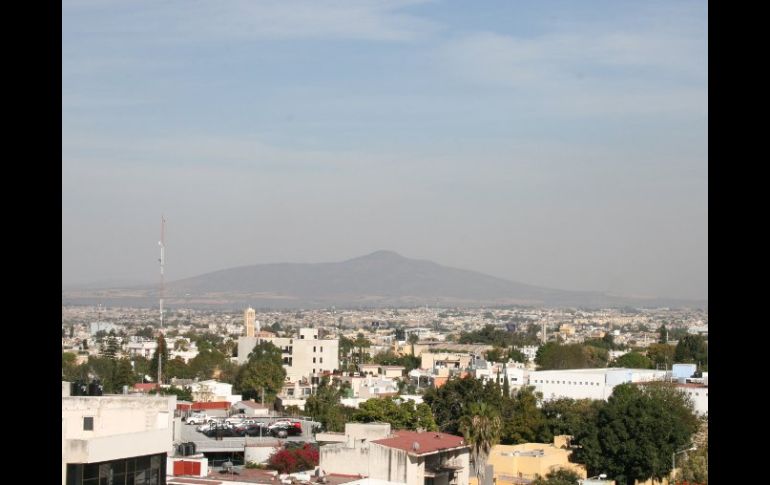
[[61, 0, 709, 485]]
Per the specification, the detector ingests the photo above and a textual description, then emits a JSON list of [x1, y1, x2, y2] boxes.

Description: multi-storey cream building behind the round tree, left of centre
[[238, 328, 339, 382]]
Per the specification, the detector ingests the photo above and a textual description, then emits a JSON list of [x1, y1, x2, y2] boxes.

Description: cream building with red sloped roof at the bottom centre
[[318, 423, 470, 485]]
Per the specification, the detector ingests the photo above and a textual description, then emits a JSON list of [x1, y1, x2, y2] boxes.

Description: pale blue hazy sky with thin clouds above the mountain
[[62, 0, 708, 298]]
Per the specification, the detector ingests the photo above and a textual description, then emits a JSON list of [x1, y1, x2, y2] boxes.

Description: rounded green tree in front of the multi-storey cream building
[[236, 341, 286, 403]]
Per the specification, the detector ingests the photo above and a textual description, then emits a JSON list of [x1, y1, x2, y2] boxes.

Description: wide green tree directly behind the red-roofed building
[[353, 397, 438, 431]]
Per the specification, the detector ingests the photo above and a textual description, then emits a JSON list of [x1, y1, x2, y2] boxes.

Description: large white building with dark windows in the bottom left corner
[[61, 384, 181, 485]]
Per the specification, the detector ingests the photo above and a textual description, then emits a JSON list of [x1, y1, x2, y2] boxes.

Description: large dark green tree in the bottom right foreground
[[573, 383, 698, 485]]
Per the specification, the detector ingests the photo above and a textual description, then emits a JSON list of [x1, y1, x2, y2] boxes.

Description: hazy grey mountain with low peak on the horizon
[[63, 251, 704, 308]]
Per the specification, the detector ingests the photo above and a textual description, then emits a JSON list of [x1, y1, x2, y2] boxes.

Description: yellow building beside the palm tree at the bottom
[[474, 435, 587, 485]]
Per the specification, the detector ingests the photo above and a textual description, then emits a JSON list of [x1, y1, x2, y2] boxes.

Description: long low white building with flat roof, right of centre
[[529, 367, 666, 401]]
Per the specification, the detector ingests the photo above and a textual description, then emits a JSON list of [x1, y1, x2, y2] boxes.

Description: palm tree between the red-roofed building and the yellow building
[[460, 402, 502, 485]]
